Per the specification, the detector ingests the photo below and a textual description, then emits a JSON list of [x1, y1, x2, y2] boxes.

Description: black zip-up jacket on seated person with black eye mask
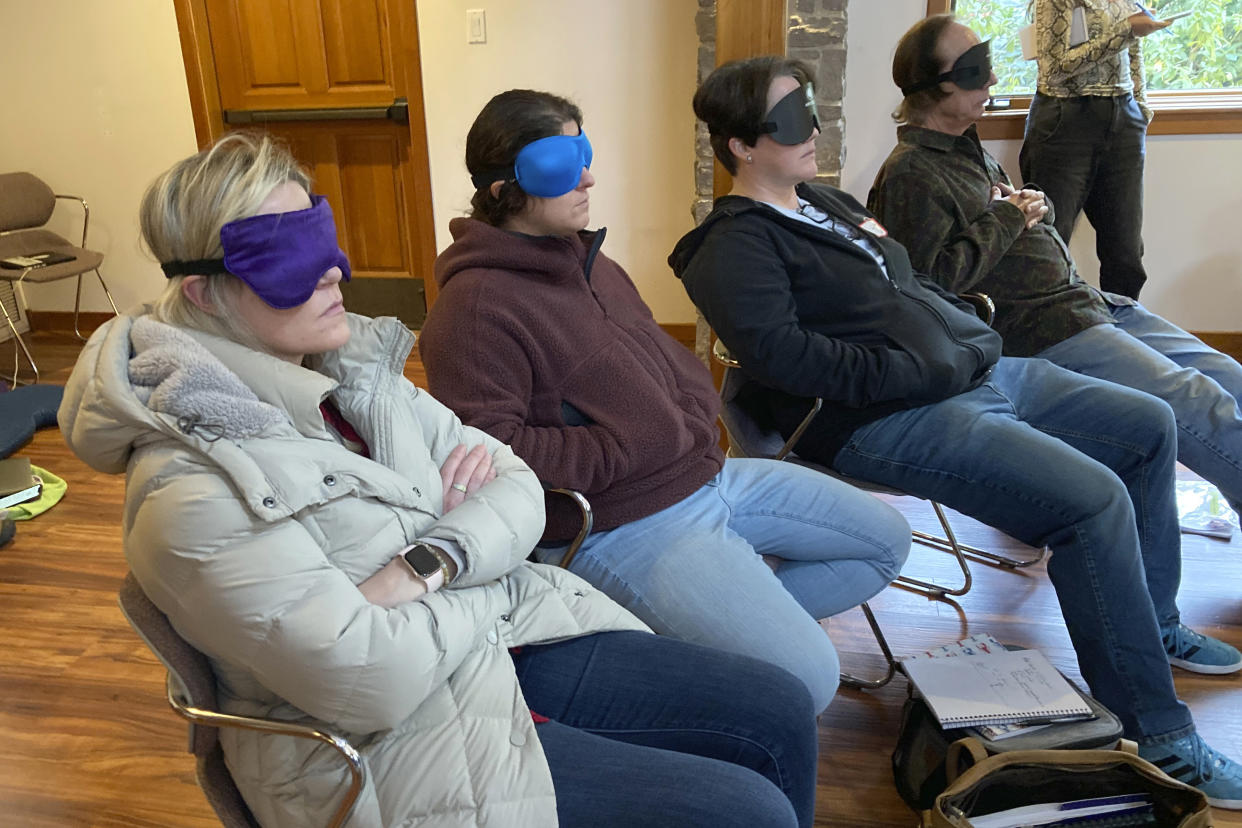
[[668, 184, 1001, 463]]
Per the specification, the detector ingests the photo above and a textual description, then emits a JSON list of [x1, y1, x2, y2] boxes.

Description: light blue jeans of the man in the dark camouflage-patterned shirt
[[1040, 302, 1242, 509]]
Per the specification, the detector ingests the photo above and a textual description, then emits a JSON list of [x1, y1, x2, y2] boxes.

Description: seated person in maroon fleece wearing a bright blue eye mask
[[419, 89, 910, 710]]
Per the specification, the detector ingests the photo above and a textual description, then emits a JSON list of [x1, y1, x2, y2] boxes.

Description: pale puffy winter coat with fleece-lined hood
[[60, 312, 643, 828]]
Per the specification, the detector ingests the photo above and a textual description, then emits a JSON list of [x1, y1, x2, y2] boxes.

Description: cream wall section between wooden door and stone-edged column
[[419, 0, 698, 323]]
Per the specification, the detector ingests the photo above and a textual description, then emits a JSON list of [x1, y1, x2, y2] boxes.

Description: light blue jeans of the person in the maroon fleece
[[535, 458, 910, 710]]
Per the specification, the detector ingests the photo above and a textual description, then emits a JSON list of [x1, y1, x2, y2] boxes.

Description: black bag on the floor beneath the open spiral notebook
[[893, 682, 1122, 813]]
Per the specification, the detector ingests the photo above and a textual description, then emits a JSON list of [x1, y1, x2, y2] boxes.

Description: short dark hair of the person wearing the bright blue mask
[[466, 89, 582, 227]]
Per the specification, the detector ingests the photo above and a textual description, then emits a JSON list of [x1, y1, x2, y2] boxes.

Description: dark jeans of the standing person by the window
[[1018, 94, 1148, 299]]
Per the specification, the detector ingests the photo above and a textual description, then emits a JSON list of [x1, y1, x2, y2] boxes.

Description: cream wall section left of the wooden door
[[0, 0, 196, 310]]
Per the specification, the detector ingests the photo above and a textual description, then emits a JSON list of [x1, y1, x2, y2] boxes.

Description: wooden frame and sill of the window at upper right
[[928, 0, 1242, 139]]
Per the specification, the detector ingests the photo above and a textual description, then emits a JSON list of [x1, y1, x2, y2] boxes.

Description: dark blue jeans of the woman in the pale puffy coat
[[513, 632, 818, 828]]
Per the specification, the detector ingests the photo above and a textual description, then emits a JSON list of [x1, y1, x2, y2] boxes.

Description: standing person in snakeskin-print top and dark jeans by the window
[[1018, 0, 1169, 299]]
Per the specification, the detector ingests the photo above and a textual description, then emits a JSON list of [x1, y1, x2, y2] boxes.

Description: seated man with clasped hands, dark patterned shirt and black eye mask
[[867, 15, 1242, 518]]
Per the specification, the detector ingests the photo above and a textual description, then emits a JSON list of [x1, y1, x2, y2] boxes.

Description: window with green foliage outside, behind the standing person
[[928, 0, 1242, 138]]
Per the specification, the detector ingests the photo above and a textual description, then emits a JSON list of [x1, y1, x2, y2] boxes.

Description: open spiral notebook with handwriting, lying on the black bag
[[902, 649, 1094, 729]]
